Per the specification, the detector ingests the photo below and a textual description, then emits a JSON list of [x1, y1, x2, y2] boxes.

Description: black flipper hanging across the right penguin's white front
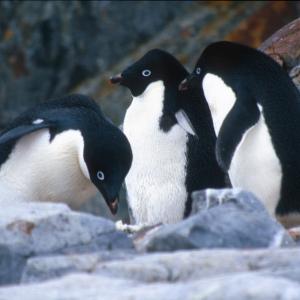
[[216, 99, 260, 171]]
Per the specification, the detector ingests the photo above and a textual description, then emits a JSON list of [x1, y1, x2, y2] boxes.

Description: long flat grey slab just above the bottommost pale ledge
[[22, 248, 300, 283]]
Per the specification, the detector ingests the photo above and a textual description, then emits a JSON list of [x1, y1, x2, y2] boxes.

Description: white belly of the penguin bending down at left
[[0, 129, 96, 208]]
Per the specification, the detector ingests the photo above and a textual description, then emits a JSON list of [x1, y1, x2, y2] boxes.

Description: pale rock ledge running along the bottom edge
[[0, 273, 300, 300]]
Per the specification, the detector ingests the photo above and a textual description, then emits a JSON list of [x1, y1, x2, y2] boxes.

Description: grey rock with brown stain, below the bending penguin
[[0, 202, 132, 284]]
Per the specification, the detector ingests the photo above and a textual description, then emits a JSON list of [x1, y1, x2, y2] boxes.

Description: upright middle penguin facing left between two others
[[111, 49, 225, 224]]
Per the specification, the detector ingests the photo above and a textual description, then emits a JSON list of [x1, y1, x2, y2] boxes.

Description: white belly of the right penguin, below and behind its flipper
[[229, 115, 282, 215]]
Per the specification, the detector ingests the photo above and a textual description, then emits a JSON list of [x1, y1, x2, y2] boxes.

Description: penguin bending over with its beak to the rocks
[[0, 94, 132, 214]]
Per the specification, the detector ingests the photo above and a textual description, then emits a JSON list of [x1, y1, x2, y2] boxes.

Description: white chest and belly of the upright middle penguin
[[124, 81, 187, 224]]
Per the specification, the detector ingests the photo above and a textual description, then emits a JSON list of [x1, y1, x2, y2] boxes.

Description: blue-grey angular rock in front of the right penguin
[[135, 189, 294, 252]]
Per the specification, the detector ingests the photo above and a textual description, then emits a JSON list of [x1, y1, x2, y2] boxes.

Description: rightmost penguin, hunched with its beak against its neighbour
[[181, 42, 300, 227]]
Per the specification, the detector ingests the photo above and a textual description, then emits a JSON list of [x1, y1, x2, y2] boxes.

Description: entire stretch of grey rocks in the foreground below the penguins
[[0, 189, 300, 300]]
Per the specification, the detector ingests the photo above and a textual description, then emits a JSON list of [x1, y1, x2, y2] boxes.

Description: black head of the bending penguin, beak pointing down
[[81, 125, 132, 214]]
